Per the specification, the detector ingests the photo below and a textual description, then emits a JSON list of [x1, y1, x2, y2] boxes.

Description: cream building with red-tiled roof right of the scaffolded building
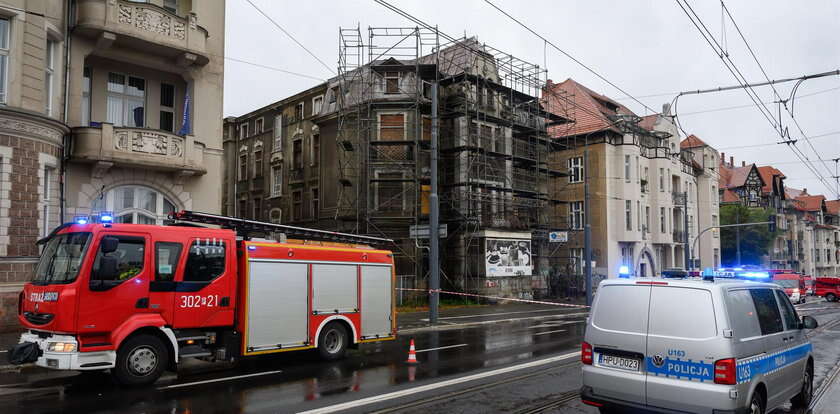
[[549, 79, 720, 284]]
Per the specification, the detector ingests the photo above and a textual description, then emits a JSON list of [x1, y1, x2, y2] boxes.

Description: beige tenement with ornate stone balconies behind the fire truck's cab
[[0, 0, 225, 329]]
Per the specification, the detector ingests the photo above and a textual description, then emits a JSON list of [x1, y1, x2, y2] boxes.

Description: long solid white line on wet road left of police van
[[298, 351, 580, 414]]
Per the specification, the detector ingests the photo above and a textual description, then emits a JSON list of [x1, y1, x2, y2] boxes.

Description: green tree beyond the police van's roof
[[720, 204, 778, 266]]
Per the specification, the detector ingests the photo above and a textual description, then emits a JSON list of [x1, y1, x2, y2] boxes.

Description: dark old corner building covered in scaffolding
[[226, 28, 571, 297]]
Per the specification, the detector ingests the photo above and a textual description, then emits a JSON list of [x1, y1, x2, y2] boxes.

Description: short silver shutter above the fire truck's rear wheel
[[312, 264, 359, 314]]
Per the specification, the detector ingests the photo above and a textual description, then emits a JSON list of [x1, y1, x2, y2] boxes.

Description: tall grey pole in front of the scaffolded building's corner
[[429, 79, 440, 325]]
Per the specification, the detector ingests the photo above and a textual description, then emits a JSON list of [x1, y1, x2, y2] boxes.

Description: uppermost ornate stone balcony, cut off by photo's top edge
[[76, 0, 210, 66]]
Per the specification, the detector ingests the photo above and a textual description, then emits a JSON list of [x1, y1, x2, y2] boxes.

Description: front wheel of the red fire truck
[[114, 335, 169, 385]]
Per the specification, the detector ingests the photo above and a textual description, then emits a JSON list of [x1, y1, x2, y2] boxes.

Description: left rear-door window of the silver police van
[[592, 285, 650, 333]]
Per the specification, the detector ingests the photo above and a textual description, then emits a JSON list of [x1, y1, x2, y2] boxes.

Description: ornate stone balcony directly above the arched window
[[73, 124, 207, 177]]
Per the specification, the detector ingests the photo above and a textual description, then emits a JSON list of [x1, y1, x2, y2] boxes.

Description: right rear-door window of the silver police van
[[648, 286, 718, 339]]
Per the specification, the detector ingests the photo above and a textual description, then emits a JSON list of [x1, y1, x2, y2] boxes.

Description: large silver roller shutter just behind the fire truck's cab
[[247, 259, 309, 351]]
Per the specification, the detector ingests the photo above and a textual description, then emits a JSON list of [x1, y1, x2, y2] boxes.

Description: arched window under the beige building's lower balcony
[[91, 185, 176, 224]]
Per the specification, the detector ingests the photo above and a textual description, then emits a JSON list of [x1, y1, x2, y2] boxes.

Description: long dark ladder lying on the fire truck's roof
[[169, 210, 394, 245]]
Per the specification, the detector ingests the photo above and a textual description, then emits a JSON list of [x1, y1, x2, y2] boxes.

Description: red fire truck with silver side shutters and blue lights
[[9, 211, 396, 385]]
